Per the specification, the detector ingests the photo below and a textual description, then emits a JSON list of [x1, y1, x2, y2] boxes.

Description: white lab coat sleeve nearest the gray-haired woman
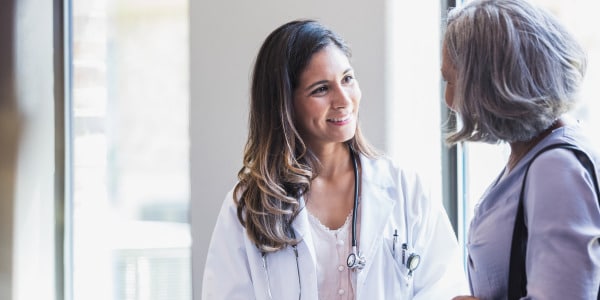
[[405, 170, 469, 300]]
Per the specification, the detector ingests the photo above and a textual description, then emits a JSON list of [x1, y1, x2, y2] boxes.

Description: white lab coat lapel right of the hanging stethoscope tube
[[357, 157, 395, 287]]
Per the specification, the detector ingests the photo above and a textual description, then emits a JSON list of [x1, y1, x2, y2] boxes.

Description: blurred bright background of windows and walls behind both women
[[0, 0, 600, 300]]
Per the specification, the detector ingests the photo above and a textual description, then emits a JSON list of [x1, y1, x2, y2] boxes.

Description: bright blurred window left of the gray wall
[[66, 0, 192, 299]]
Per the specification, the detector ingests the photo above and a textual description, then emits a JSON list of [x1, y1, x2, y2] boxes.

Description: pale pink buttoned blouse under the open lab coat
[[308, 212, 358, 300]]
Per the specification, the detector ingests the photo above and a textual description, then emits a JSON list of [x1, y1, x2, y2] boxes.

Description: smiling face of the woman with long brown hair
[[294, 45, 361, 149]]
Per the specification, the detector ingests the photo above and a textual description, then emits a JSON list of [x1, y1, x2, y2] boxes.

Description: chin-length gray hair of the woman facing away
[[444, 0, 586, 144]]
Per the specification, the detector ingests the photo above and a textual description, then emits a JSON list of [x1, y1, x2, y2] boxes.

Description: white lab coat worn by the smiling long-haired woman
[[202, 156, 468, 300]]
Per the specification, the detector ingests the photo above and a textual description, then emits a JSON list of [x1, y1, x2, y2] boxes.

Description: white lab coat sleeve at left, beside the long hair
[[202, 191, 254, 300]]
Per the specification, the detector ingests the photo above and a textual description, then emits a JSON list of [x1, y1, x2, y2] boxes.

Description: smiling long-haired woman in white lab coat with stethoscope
[[202, 20, 466, 300]]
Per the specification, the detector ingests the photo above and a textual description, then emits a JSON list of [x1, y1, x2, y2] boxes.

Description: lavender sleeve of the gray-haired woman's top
[[524, 149, 600, 299]]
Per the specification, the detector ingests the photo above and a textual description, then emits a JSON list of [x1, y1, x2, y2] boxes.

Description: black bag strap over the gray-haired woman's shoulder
[[508, 143, 600, 300]]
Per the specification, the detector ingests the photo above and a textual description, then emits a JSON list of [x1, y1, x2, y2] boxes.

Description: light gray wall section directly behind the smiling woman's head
[[190, 0, 386, 299]]
